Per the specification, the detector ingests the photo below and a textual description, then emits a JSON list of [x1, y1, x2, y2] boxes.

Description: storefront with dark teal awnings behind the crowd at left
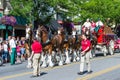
[[0, 0, 26, 41]]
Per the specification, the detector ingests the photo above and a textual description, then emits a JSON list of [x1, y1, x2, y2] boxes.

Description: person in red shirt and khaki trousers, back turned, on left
[[30, 38, 42, 77]]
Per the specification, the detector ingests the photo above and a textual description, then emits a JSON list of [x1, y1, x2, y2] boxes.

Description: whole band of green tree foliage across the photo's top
[[10, 0, 120, 23]]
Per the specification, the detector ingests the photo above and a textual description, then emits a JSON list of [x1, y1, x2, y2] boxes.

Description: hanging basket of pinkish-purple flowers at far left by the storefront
[[1, 16, 16, 26]]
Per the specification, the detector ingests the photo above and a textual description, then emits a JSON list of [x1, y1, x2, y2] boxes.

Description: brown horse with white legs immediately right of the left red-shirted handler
[[36, 26, 54, 67]]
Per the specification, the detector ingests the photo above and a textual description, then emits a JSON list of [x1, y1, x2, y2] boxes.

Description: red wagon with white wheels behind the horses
[[95, 26, 116, 56]]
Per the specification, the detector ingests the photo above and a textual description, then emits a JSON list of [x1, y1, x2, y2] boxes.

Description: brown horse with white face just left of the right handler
[[68, 28, 81, 62]]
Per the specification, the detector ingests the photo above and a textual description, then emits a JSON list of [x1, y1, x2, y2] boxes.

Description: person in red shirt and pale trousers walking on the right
[[78, 34, 92, 75]]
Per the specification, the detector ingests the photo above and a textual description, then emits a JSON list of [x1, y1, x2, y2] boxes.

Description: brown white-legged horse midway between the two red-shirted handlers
[[51, 28, 70, 65]]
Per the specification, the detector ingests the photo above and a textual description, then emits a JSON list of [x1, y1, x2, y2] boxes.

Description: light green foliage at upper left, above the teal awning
[[10, 0, 33, 17]]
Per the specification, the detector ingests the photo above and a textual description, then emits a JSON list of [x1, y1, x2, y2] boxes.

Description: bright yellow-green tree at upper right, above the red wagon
[[80, 0, 120, 23]]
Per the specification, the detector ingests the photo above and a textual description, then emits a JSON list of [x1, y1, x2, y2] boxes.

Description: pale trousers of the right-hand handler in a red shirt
[[80, 50, 91, 72]]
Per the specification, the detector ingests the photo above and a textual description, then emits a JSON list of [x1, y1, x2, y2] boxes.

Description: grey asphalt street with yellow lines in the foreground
[[0, 53, 120, 80]]
